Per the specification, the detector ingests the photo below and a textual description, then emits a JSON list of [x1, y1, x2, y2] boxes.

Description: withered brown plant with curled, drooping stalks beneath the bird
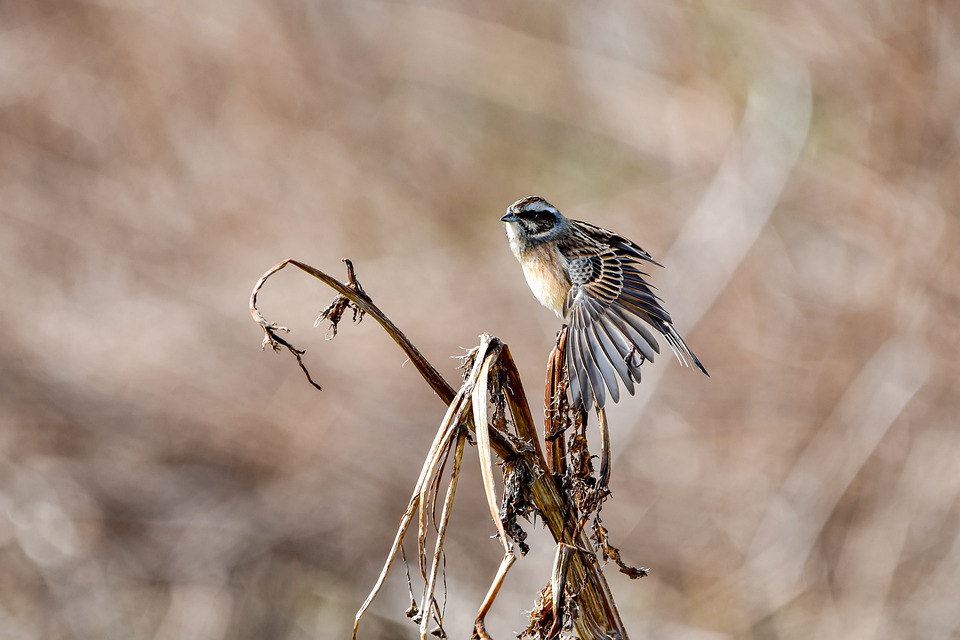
[[250, 260, 627, 640]]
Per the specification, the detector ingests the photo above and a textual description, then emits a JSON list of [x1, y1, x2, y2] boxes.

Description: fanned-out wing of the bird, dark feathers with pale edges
[[559, 221, 706, 409]]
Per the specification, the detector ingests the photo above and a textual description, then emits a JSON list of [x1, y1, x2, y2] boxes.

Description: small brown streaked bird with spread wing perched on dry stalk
[[500, 196, 710, 410]]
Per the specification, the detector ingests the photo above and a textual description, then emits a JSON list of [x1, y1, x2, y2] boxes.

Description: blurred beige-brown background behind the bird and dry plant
[[0, 0, 960, 640]]
